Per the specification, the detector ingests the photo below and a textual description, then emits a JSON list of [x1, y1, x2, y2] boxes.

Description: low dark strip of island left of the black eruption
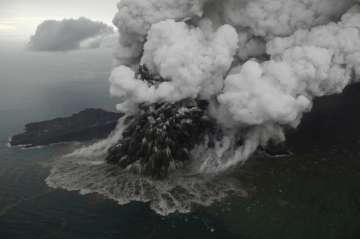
[[10, 109, 122, 147]]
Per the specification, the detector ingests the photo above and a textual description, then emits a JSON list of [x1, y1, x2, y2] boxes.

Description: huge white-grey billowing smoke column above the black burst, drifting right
[[110, 0, 360, 174]]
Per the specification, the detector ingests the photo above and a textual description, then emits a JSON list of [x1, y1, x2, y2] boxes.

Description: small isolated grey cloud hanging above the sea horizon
[[28, 17, 115, 51]]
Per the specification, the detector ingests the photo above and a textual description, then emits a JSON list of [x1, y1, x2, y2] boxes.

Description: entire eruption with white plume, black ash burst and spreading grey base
[[46, 0, 360, 215]]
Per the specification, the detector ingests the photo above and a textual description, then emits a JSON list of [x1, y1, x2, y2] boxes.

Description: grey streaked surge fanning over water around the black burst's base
[[46, 118, 247, 215]]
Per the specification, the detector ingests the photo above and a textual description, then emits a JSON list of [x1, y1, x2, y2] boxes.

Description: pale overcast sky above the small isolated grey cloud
[[0, 0, 119, 40]]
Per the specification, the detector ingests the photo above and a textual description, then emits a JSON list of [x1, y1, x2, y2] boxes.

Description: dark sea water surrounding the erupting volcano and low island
[[0, 42, 360, 239]]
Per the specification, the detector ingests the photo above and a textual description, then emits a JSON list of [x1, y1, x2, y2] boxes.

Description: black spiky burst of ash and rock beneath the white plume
[[106, 99, 212, 179]]
